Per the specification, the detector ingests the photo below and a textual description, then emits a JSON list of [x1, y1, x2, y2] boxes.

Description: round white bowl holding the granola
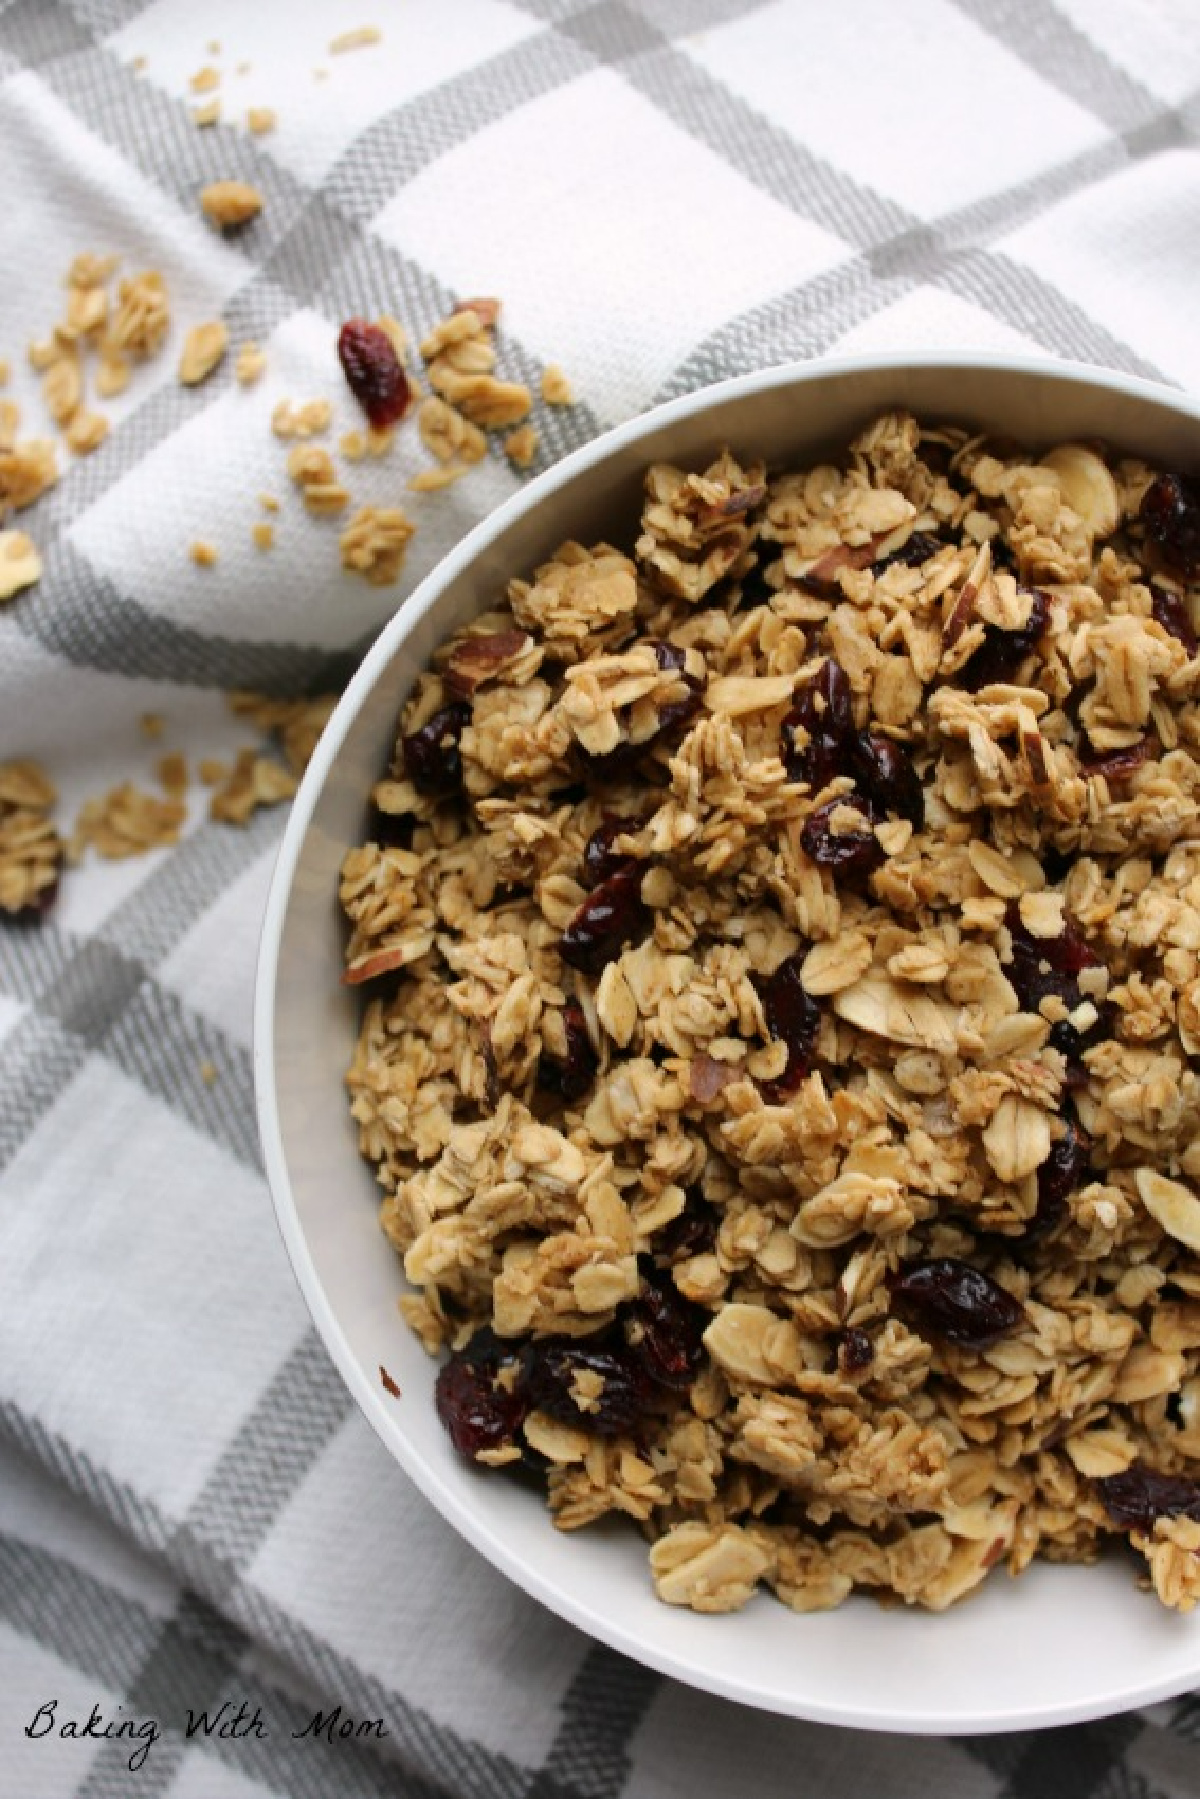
[[255, 356, 1200, 1732]]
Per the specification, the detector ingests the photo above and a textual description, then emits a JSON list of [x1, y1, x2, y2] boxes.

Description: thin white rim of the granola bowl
[[252, 351, 1200, 1734]]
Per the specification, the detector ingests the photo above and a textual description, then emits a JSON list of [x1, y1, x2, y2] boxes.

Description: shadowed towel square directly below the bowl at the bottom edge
[[626, 1683, 1000, 1799]]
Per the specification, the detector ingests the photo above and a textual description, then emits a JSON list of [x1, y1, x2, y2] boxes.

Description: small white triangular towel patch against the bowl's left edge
[[158, 846, 275, 1049]]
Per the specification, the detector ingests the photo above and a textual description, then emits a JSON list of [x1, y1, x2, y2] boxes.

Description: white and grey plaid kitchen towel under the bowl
[[0, 0, 1200, 1799]]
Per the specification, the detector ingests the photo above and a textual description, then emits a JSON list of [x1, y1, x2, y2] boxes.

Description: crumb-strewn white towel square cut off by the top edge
[[108, 0, 538, 187]]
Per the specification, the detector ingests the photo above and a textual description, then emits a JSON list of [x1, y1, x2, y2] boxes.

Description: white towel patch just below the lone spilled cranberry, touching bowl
[[70, 309, 516, 649]]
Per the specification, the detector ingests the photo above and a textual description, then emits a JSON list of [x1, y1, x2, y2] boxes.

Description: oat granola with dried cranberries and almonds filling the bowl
[[342, 414, 1200, 1612]]
